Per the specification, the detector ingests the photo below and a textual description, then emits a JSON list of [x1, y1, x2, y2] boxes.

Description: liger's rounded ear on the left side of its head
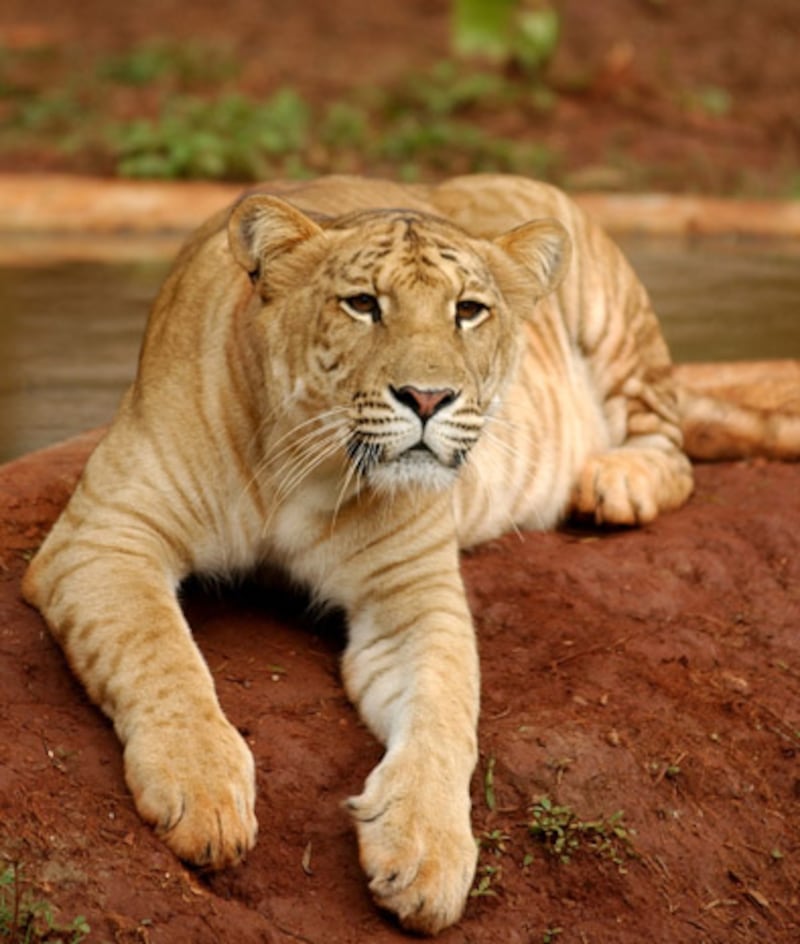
[[228, 194, 322, 282]]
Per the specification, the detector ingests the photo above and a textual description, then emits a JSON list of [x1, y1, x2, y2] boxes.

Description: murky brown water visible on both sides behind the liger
[[0, 237, 800, 462]]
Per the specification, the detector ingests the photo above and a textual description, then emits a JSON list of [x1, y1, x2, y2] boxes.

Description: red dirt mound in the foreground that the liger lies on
[[0, 435, 800, 944]]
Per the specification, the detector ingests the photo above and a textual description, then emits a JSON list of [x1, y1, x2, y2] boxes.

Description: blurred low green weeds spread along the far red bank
[[0, 40, 560, 181]]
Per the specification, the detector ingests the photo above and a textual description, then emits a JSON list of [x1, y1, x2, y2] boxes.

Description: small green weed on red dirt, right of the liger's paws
[[528, 796, 636, 872]]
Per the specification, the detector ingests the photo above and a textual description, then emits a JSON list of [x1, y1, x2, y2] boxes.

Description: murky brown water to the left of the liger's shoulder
[[0, 261, 167, 462]]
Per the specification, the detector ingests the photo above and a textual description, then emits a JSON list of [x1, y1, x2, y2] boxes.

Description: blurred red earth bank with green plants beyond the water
[[0, 0, 800, 197]]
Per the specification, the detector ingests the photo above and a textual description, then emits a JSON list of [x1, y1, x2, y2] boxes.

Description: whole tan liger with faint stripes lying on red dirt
[[24, 177, 788, 933]]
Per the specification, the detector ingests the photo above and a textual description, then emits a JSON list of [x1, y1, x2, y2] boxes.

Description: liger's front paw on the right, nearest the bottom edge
[[348, 765, 478, 934]]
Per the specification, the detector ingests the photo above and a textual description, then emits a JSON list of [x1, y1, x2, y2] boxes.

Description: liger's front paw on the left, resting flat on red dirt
[[125, 715, 258, 869]]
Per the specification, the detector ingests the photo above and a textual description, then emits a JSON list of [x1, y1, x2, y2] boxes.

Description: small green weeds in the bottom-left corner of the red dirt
[[0, 862, 89, 944]]
